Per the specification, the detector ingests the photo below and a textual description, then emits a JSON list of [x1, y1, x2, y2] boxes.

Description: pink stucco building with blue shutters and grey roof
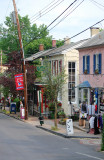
[[78, 28, 104, 112]]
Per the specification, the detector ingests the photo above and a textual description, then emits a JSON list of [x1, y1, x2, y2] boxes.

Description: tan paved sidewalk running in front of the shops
[[0, 112, 101, 139]]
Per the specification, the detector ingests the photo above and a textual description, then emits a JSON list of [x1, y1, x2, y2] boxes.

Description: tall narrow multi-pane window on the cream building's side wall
[[68, 62, 75, 102]]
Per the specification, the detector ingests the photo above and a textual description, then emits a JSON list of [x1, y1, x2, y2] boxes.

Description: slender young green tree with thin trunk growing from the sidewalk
[[41, 60, 67, 128]]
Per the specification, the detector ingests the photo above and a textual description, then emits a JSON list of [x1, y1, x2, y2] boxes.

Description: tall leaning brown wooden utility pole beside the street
[[13, 0, 28, 119]]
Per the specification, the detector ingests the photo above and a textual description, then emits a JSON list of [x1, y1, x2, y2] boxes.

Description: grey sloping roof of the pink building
[[77, 31, 104, 49]]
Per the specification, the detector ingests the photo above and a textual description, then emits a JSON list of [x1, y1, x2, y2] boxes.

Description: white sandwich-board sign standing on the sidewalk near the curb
[[66, 119, 74, 135]]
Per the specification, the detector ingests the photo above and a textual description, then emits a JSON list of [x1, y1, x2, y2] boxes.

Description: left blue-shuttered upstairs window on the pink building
[[83, 55, 90, 74]]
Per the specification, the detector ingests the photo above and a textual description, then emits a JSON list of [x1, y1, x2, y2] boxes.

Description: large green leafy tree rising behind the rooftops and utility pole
[[0, 15, 63, 57]]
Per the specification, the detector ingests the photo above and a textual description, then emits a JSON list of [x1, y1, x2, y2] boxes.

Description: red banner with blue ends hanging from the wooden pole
[[15, 73, 24, 90]]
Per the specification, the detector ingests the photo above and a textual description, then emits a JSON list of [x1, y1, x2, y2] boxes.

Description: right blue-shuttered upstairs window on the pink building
[[93, 53, 102, 74]]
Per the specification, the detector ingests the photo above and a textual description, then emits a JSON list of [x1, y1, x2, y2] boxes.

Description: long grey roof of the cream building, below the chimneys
[[25, 39, 86, 61]]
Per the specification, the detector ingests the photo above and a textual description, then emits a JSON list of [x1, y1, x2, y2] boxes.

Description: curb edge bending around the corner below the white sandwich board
[[36, 126, 100, 139]]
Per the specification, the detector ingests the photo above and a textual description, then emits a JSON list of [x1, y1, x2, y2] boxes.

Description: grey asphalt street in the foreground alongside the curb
[[0, 113, 104, 160]]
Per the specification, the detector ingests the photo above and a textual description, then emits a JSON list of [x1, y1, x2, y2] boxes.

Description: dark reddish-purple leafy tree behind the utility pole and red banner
[[0, 52, 36, 97]]
